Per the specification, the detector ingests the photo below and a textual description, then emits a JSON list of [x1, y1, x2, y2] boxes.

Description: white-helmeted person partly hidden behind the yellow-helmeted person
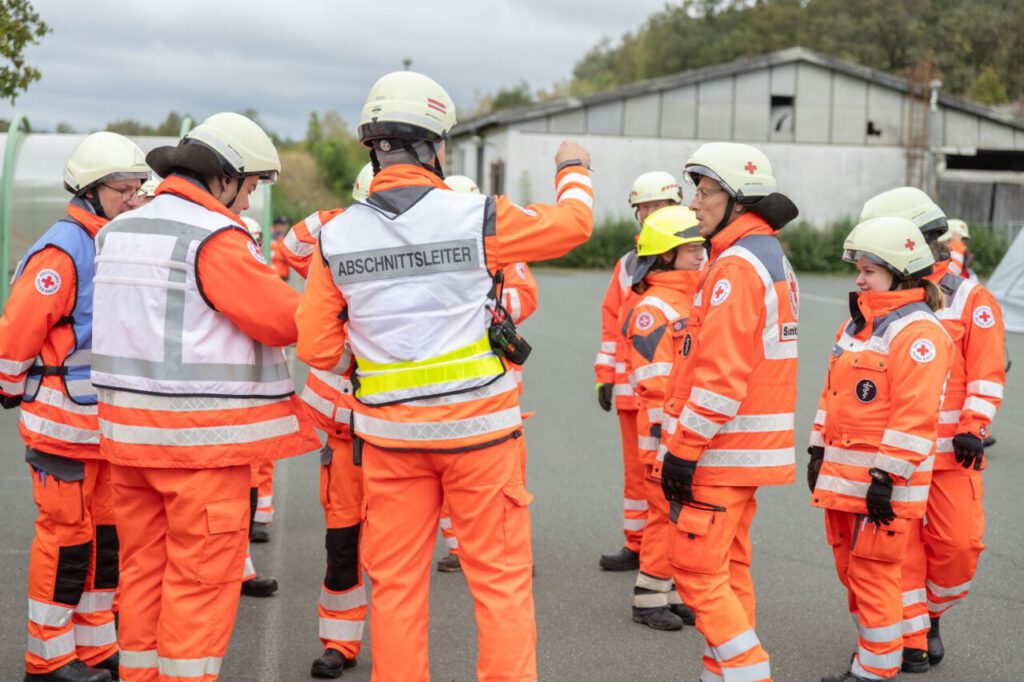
[[594, 171, 683, 570]]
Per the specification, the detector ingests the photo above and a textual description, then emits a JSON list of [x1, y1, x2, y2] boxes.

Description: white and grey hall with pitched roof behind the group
[[447, 47, 1024, 225]]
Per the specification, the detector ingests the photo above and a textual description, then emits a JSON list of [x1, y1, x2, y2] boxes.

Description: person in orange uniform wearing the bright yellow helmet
[[626, 206, 705, 630]]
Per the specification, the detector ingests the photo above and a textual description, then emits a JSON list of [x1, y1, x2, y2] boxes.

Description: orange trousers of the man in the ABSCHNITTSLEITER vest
[[362, 438, 537, 682]]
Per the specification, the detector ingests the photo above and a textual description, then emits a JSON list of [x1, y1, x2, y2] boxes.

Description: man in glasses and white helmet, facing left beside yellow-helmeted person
[[662, 142, 799, 682]]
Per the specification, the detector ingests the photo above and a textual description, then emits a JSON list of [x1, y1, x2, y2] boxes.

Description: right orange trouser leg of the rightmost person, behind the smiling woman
[[922, 467, 985, 617]]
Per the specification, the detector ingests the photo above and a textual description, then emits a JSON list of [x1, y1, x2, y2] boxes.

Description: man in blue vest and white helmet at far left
[[0, 132, 150, 682]]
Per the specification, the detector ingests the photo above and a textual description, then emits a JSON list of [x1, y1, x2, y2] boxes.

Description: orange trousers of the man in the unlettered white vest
[[112, 458, 250, 682]]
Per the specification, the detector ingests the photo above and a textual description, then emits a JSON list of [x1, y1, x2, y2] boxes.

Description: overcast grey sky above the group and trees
[[0, 0, 666, 138]]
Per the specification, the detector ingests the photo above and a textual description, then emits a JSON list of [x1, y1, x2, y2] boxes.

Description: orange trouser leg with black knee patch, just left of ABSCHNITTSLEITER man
[[316, 435, 367, 660]]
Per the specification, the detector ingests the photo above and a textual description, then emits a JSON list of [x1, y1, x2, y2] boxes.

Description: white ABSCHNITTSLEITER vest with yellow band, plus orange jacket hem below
[[321, 186, 522, 451]]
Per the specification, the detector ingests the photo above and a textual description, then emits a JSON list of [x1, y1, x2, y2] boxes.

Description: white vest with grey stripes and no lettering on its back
[[92, 194, 295, 398]]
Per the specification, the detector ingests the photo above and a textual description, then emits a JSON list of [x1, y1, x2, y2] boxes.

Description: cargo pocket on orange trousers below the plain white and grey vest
[[196, 493, 249, 585]]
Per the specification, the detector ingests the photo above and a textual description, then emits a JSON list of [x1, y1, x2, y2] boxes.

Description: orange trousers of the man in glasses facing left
[[669, 485, 771, 682]]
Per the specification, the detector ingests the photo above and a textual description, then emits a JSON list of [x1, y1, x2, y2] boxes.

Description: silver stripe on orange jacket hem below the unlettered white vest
[[99, 415, 299, 447]]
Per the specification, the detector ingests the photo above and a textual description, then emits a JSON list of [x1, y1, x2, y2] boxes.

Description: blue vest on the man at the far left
[[14, 206, 96, 404]]
